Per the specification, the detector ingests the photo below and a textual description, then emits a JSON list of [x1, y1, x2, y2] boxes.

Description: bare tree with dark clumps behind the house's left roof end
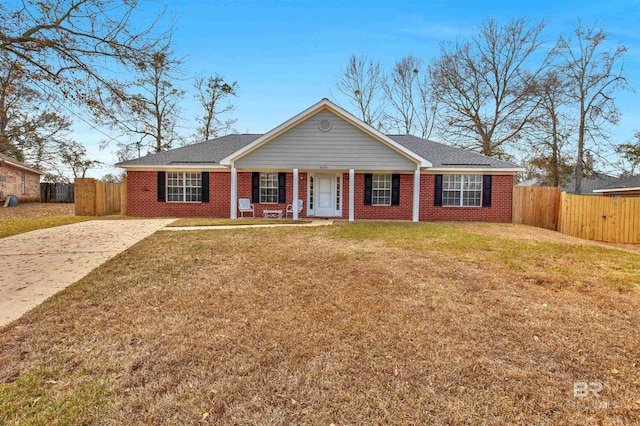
[[103, 45, 185, 157]]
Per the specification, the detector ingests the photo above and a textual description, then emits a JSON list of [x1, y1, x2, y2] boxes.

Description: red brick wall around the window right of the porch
[[420, 174, 513, 222]]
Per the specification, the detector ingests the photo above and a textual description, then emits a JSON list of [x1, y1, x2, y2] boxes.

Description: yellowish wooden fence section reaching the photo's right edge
[[558, 193, 640, 244]]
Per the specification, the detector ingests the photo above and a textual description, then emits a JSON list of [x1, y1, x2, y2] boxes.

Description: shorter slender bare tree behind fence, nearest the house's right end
[[527, 70, 573, 186]]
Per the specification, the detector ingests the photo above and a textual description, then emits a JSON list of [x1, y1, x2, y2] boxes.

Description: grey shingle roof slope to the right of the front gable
[[388, 135, 520, 169]]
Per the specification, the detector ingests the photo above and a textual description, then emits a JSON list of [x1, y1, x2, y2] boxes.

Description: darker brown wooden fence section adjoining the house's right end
[[511, 186, 560, 231]]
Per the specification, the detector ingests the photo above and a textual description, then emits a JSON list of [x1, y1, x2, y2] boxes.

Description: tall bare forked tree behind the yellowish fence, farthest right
[[554, 21, 628, 194]]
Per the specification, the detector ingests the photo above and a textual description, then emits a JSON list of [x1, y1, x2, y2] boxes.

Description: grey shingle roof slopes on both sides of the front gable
[[116, 134, 519, 169]]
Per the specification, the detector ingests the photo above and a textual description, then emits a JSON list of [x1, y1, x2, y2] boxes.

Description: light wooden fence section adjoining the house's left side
[[75, 178, 127, 216]]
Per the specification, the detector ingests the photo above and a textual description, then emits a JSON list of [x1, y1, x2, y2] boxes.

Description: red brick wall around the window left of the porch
[[127, 171, 231, 217]]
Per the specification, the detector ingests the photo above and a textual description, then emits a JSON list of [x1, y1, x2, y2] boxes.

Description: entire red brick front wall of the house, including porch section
[[127, 171, 513, 222]]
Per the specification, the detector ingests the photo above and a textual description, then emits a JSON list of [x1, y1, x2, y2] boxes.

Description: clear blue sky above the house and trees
[[70, 0, 640, 176]]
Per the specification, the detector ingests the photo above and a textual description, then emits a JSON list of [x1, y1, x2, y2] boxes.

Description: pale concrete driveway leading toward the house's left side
[[0, 219, 174, 327]]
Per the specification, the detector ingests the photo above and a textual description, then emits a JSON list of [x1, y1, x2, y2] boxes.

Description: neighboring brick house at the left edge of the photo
[[0, 154, 42, 201]]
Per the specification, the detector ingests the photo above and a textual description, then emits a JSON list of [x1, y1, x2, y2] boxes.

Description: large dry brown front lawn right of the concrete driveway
[[0, 223, 640, 425]]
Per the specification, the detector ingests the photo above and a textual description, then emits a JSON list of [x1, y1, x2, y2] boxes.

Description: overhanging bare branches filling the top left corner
[[0, 0, 164, 114]]
